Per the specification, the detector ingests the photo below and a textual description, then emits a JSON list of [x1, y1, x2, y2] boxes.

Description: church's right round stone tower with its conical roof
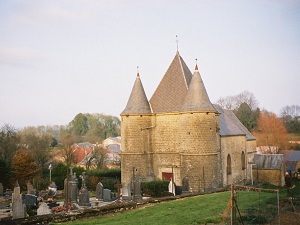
[[180, 64, 221, 191]]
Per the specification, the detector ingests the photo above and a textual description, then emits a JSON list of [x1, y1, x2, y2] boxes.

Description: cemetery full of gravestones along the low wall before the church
[[0, 168, 206, 224]]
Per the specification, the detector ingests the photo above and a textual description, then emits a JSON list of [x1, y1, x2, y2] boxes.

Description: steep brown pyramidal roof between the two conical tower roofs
[[150, 51, 192, 113]]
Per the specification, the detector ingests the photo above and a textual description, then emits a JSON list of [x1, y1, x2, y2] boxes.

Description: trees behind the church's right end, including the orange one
[[217, 91, 300, 153]]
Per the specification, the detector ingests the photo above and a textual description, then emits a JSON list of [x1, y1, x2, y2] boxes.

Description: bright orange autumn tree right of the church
[[254, 111, 288, 154]]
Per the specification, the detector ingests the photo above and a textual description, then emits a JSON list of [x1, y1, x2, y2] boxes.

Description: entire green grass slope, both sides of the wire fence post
[[51, 179, 300, 225]]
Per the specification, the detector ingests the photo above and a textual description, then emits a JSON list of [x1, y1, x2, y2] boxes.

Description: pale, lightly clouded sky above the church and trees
[[0, 0, 300, 129]]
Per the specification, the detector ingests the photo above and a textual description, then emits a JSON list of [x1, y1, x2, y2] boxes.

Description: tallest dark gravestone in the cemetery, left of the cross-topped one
[[64, 167, 78, 207]]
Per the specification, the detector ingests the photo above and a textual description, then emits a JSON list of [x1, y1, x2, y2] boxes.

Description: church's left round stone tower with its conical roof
[[121, 73, 152, 193]]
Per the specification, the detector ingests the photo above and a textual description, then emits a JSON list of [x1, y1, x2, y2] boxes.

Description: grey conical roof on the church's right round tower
[[181, 65, 216, 111]]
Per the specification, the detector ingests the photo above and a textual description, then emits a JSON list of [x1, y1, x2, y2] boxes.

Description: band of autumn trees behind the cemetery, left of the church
[[0, 113, 120, 191]]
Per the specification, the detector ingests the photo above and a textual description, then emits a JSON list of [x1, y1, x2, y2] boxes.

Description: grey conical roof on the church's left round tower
[[121, 73, 151, 115]]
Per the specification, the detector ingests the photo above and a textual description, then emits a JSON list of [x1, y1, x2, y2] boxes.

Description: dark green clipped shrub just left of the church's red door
[[141, 180, 169, 197]]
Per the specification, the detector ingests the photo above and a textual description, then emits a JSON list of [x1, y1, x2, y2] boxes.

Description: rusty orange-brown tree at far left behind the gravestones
[[12, 149, 40, 188]]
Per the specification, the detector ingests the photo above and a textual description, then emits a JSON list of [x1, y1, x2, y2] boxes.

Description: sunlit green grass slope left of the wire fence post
[[56, 192, 230, 225]]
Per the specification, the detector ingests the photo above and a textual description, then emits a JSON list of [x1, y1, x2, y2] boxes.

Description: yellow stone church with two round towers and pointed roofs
[[121, 51, 256, 195]]
